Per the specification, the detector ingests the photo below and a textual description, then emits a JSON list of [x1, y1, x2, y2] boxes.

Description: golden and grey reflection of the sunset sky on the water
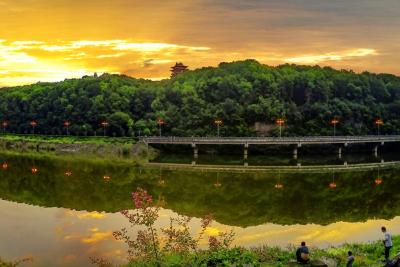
[[0, 200, 400, 267]]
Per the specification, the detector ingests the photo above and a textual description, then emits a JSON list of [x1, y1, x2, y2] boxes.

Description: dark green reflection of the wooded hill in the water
[[0, 156, 400, 226]]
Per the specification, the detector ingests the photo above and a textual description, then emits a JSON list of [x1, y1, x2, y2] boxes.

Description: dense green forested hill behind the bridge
[[0, 60, 400, 136]]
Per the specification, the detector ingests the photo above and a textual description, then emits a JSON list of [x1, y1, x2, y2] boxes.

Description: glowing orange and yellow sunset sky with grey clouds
[[0, 0, 400, 87]]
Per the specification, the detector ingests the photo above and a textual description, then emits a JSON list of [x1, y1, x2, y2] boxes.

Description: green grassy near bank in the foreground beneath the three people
[[118, 236, 400, 267]]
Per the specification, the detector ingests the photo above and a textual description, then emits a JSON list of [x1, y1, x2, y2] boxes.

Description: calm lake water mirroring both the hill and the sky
[[0, 154, 400, 266]]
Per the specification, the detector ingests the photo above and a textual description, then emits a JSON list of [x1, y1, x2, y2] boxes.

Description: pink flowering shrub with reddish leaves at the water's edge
[[109, 188, 234, 265]]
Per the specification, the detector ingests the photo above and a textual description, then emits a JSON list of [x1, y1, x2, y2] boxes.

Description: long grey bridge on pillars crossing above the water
[[141, 135, 400, 159]]
